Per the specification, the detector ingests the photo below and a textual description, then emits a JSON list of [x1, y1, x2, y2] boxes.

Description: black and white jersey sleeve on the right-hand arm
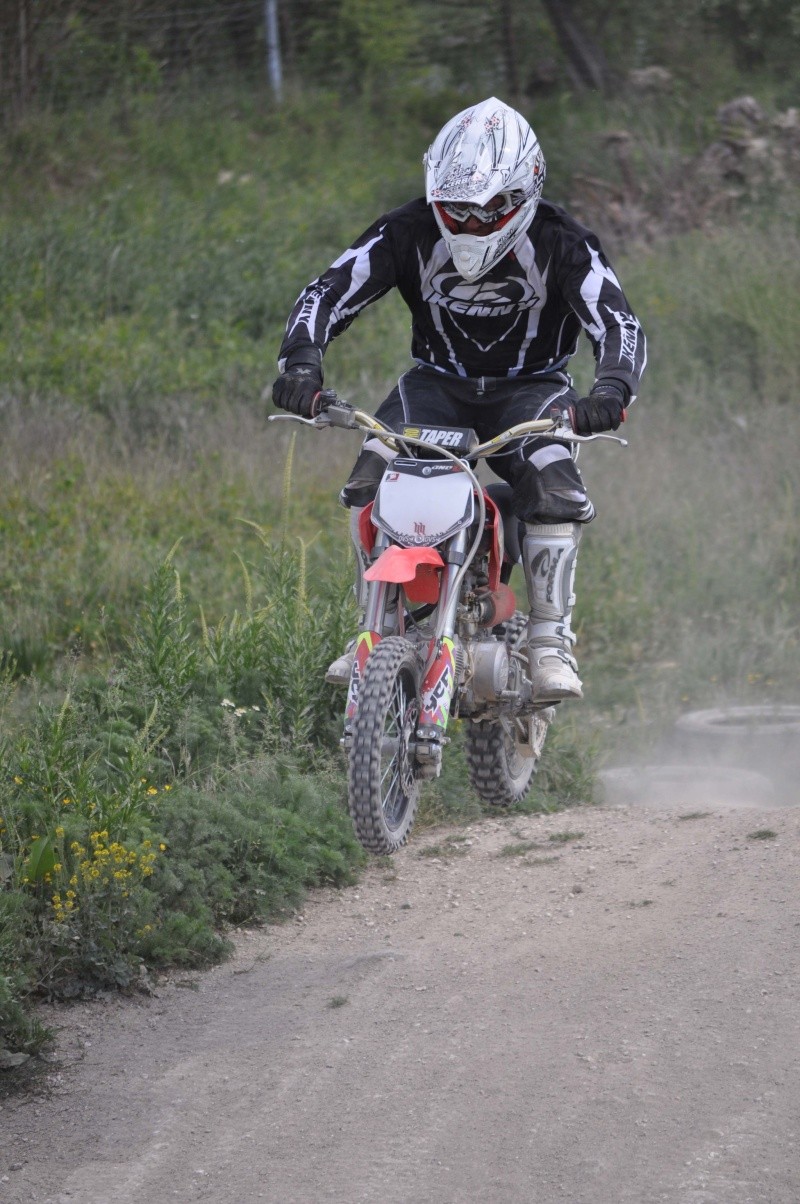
[[560, 236, 647, 400]]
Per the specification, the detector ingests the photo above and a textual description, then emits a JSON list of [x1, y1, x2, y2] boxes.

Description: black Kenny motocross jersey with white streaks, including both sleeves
[[280, 197, 646, 396]]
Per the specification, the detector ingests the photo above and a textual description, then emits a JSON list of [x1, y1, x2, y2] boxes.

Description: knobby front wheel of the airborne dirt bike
[[348, 636, 422, 854]]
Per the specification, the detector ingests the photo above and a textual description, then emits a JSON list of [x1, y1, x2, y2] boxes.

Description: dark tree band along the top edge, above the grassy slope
[[6, 0, 800, 123]]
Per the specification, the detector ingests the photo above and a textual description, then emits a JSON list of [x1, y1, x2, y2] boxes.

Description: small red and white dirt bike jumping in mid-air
[[271, 393, 624, 854]]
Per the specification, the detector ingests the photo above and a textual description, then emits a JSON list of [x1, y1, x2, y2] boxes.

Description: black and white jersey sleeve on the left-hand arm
[[278, 217, 396, 371]]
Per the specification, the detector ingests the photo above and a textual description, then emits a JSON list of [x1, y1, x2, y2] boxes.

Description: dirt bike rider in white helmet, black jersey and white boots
[[272, 96, 646, 702]]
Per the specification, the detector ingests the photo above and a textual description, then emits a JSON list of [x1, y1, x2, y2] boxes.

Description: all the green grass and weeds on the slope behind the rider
[[0, 70, 800, 1052]]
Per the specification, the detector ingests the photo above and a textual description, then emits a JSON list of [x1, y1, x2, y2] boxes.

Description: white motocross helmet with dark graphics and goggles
[[423, 96, 545, 283]]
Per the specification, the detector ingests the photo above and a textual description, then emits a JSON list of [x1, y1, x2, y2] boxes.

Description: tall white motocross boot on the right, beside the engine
[[522, 523, 583, 702]]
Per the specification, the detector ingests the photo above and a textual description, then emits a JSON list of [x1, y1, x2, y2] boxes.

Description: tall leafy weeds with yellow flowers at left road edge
[[0, 532, 363, 1047]]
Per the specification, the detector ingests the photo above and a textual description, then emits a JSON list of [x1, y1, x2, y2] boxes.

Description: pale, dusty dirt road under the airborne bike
[[0, 802, 800, 1204]]
